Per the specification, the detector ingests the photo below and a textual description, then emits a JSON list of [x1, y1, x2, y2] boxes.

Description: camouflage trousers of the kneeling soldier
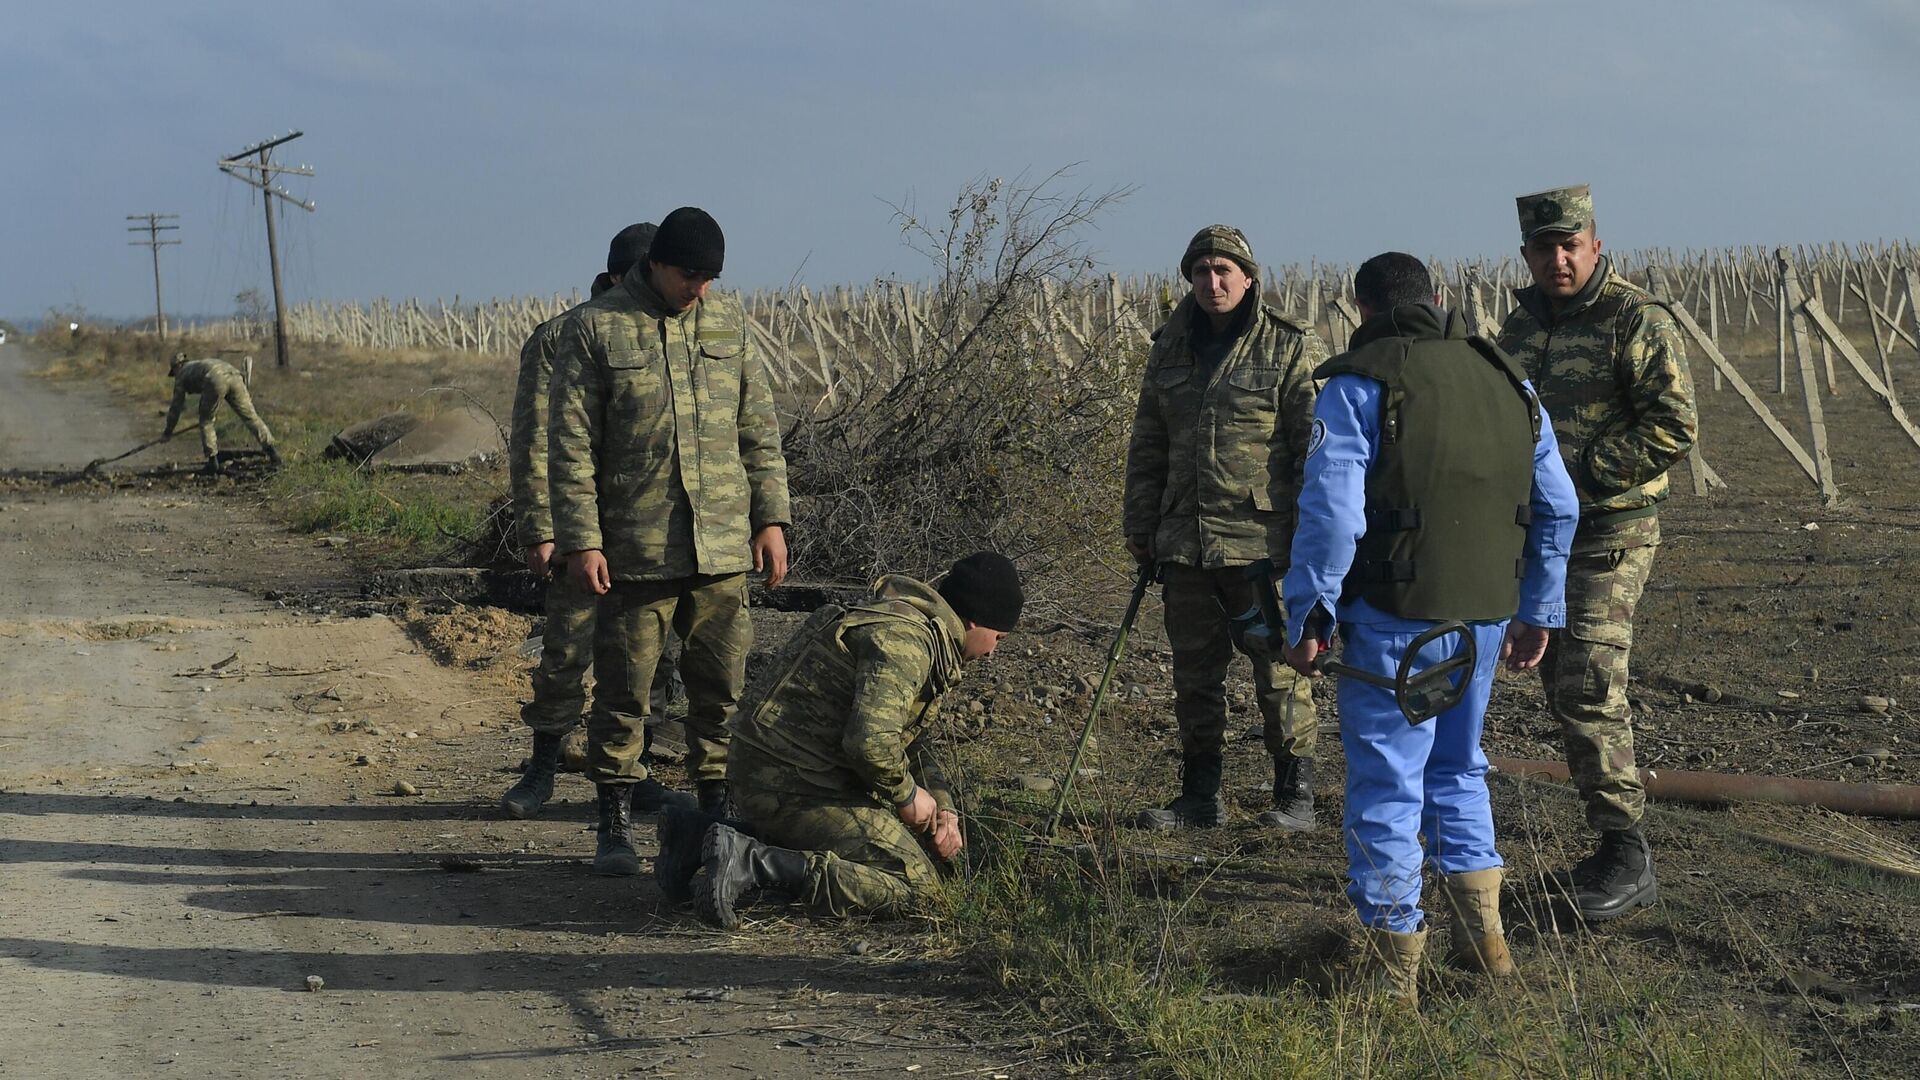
[[728, 749, 941, 919]]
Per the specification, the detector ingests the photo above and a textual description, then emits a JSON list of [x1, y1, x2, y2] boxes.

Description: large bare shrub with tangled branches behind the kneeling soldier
[[787, 171, 1144, 607]]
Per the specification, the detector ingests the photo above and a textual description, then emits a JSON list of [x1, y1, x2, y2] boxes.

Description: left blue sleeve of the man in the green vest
[[1281, 375, 1380, 646]]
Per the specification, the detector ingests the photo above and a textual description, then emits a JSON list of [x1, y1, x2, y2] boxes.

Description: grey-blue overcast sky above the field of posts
[[0, 0, 1920, 317]]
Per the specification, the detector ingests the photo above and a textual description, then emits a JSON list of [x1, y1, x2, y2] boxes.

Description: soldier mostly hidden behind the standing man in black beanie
[[501, 223, 691, 819]]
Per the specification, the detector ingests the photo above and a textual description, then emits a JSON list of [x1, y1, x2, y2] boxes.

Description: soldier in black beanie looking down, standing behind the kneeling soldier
[[547, 208, 791, 874]]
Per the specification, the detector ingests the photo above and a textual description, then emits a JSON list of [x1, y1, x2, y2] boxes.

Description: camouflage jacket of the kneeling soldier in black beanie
[[728, 575, 966, 809]]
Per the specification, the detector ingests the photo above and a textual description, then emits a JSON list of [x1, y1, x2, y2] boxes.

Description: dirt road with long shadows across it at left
[[0, 346, 1046, 1080]]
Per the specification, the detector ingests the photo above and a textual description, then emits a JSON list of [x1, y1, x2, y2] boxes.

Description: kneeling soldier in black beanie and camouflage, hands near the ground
[[657, 552, 1023, 928]]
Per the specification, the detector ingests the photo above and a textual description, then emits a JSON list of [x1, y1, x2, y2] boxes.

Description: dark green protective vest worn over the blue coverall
[[1313, 307, 1540, 623]]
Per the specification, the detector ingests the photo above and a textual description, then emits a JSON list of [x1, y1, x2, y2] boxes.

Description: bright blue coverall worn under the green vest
[[1281, 373, 1580, 934]]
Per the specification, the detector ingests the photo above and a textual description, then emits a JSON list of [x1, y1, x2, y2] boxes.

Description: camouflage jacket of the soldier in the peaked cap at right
[[1500, 261, 1699, 552]]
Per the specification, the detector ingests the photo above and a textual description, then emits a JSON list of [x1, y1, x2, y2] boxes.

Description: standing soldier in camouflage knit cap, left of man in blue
[[1125, 225, 1327, 830]]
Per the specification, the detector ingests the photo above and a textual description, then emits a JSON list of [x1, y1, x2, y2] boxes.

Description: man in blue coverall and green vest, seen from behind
[[1283, 252, 1576, 1005]]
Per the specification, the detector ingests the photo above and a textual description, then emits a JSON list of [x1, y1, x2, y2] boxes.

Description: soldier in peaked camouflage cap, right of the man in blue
[[1500, 184, 1697, 920]]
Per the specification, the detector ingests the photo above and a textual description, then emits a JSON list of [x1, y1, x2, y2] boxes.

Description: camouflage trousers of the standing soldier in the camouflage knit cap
[[1160, 563, 1319, 757]]
